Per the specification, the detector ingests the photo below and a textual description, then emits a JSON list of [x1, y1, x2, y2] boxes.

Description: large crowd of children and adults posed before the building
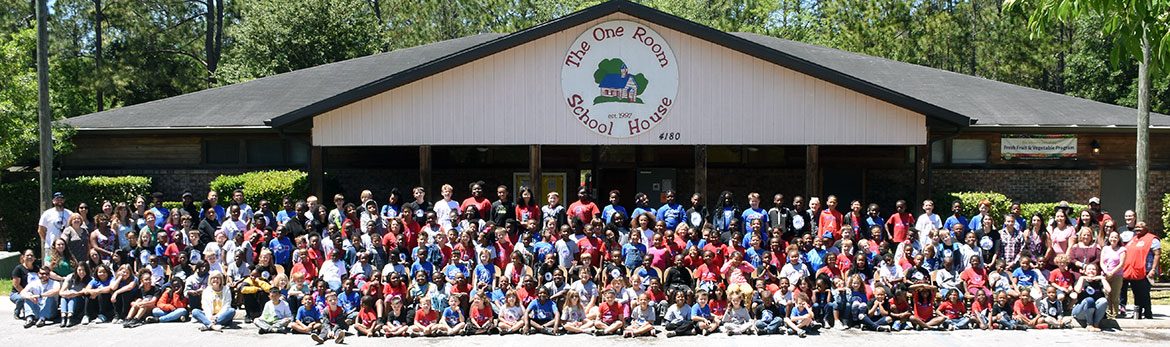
[[11, 182, 1161, 343]]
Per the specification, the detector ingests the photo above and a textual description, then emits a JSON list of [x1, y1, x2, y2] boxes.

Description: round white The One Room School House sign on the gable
[[560, 20, 679, 138]]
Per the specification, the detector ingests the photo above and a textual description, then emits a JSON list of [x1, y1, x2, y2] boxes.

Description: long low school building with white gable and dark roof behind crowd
[[60, 1, 1170, 222]]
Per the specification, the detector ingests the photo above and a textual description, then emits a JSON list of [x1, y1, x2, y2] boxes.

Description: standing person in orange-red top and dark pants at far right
[[1122, 222, 1162, 319]]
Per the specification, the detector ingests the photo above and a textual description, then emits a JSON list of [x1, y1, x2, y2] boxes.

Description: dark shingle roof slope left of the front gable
[[66, 34, 503, 130]]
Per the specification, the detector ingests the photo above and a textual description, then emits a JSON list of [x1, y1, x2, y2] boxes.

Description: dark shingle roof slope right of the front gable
[[734, 33, 1170, 127]]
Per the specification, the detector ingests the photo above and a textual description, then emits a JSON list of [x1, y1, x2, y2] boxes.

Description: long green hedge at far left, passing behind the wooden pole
[[0, 176, 151, 250]]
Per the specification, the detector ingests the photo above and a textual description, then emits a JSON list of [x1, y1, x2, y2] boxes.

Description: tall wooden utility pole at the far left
[[36, 0, 53, 210]]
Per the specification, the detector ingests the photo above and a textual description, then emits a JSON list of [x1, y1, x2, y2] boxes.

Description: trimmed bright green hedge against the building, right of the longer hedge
[[209, 171, 309, 208]]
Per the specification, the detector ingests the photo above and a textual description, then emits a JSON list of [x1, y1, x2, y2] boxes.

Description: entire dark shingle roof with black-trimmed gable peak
[[66, 0, 1170, 130]]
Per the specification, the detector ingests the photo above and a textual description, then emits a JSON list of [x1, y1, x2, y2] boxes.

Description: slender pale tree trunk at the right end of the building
[[1134, 25, 1164, 221]]
